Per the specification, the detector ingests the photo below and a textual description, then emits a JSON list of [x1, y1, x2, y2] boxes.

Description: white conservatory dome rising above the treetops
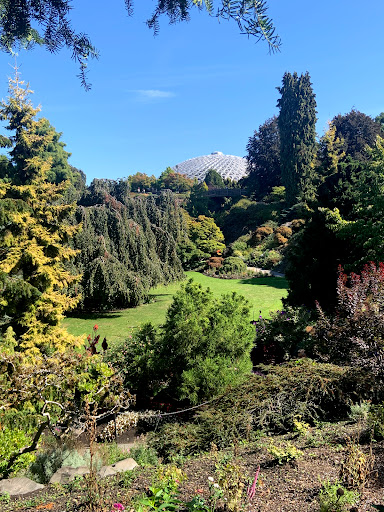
[[173, 151, 247, 181]]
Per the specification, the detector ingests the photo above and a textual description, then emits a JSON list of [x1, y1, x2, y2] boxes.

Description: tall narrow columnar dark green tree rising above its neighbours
[[277, 72, 316, 205]]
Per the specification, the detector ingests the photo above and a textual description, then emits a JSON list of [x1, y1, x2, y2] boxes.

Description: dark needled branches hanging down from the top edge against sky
[[0, 0, 280, 88]]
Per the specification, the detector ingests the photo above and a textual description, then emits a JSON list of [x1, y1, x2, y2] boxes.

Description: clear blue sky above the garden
[[0, 0, 384, 182]]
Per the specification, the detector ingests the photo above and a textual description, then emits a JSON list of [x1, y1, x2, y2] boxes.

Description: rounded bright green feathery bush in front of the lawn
[[157, 280, 254, 403]]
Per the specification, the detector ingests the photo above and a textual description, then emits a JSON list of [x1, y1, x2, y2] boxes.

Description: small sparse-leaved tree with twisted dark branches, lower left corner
[[0, 347, 133, 478]]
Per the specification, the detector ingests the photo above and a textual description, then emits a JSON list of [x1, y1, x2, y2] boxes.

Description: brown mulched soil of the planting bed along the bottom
[[4, 426, 384, 512]]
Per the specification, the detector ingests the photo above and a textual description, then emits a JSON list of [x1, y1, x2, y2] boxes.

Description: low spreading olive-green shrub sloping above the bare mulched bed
[[149, 359, 355, 459]]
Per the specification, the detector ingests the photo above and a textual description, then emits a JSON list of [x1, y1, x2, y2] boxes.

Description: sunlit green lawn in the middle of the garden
[[63, 272, 287, 341]]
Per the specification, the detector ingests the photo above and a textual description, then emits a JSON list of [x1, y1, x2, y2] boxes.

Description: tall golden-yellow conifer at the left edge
[[0, 70, 78, 355]]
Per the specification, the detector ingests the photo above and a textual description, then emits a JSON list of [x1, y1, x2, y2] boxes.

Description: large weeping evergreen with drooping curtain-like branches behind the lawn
[[75, 185, 187, 309]]
